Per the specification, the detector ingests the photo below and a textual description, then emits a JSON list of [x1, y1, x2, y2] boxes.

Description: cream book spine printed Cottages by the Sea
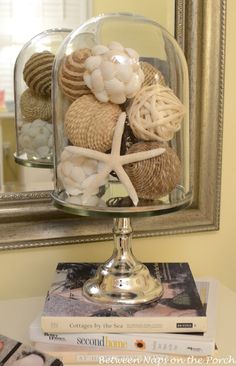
[[41, 316, 207, 333]]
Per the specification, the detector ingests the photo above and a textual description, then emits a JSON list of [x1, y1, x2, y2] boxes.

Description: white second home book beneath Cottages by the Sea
[[29, 279, 217, 358]]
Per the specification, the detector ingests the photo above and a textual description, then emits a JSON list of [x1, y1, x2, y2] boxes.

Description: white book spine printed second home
[[30, 328, 215, 356]]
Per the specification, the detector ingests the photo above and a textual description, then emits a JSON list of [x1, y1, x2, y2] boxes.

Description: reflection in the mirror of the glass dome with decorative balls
[[14, 29, 71, 168]]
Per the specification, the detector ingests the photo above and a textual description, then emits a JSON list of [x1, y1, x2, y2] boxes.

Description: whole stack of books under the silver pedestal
[[30, 263, 217, 365]]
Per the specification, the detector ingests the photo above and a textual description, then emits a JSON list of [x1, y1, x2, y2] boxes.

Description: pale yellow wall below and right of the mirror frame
[[0, 0, 236, 298]]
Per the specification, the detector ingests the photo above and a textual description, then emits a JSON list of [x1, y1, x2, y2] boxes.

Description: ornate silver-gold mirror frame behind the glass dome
[[0, 0, 226, 249]]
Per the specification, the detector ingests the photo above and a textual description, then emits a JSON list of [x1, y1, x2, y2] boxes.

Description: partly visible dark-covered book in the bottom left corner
[[0, 335, 63, 366]]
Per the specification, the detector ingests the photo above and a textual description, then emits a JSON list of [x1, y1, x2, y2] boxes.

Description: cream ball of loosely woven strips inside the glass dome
[[128, 84, 185, 141]]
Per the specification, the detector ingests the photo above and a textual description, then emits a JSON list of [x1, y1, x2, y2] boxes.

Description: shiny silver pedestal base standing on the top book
[[83, 218, 163, 305]]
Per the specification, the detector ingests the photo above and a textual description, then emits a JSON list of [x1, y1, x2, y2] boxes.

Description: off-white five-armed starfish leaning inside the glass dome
[[66, 112, 165, 206]]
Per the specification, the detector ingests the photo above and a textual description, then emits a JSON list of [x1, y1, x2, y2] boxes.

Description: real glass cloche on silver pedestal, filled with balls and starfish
[[53, 14, 191, 304]]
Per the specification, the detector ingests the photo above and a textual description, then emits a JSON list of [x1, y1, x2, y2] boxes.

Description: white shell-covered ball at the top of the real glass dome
[[84, 42, 144, 104]]
